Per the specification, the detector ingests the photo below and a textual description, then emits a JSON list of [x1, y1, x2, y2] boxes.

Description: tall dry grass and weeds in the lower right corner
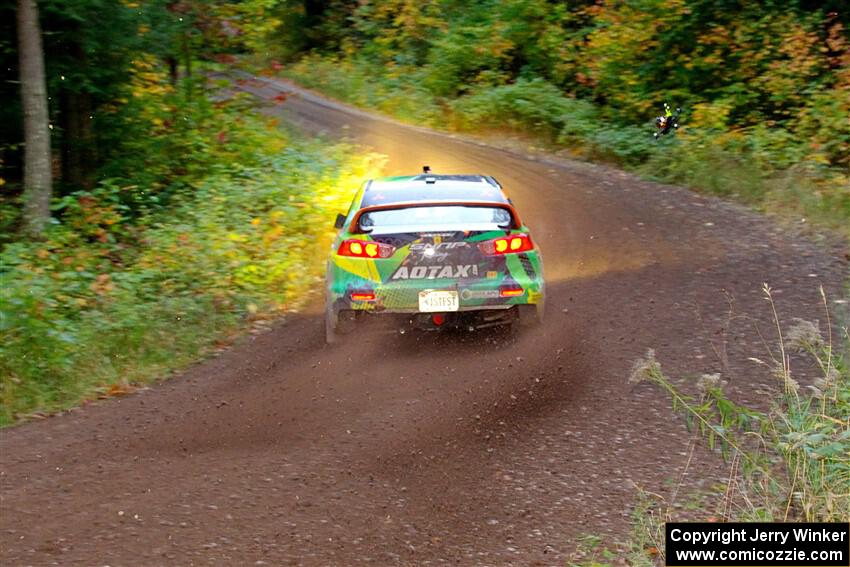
[[568, 285, 850, 567]]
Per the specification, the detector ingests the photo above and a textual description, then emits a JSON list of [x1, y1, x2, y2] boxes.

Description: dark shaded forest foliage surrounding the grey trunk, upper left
[[0, 0, 252, 195]]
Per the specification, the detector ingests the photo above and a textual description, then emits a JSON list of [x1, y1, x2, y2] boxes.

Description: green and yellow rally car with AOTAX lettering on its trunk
[[325, 166, 544, 343]]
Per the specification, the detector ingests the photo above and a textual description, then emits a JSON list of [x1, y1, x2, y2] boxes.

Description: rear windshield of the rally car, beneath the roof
[[358, 205, 514, 234]]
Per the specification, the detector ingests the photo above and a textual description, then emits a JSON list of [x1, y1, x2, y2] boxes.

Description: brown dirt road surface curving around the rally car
[[0, 76, 847, 566]]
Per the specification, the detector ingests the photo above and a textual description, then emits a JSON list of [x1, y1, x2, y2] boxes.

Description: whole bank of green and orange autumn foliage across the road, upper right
[[279, 0, 850, 235]]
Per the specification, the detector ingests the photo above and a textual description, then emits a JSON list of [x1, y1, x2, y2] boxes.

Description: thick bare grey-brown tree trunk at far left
[[18, 0, 53, 237]]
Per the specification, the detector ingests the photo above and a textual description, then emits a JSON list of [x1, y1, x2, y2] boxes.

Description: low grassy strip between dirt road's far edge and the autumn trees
[[283, 55, 850, 242]]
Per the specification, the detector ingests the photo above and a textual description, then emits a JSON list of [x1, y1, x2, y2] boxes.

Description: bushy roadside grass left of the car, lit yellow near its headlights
[[0, 74, 379, 425]]
